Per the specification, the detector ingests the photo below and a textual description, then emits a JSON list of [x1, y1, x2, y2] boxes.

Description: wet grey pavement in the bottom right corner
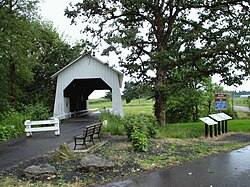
[[103, 146, 250, 187]]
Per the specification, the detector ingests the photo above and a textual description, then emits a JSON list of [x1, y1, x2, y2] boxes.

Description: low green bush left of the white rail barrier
[[0, 109, 25, 141]]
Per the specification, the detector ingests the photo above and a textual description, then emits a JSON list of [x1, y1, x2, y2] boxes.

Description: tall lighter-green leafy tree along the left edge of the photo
[[0, 0, 38, 109]]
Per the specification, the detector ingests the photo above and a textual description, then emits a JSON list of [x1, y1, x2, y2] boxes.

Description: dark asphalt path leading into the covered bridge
[[0, 113, 98, 172]]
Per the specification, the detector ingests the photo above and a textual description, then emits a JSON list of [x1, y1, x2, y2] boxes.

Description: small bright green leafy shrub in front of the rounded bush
[[131, 126, 148, 152]]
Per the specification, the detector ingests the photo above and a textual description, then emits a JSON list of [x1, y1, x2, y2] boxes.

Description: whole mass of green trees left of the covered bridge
[[0, 0, 83, 112]]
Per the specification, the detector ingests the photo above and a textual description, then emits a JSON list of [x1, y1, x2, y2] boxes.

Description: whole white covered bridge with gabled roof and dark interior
[[52, 55, 123, 119]]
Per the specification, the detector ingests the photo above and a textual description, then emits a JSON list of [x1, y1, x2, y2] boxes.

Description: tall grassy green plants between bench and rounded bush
[[100, 112, 124, 135]]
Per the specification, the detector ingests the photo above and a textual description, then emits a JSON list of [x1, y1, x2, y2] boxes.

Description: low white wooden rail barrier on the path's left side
[[24, 118, 60, 137]]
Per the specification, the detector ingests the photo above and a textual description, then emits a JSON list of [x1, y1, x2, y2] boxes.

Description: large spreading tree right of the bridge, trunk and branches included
[[65, 0, 250, 124]]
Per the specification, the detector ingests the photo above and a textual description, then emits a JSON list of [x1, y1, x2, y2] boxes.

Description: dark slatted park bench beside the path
[[74, 122, 102, 150]]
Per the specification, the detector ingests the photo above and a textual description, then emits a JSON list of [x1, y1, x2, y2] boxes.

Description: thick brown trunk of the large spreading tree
[[155, 68, 166, 125]]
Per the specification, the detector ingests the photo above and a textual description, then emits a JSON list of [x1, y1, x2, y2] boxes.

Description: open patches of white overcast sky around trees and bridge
[[40, 0, 250, 93]]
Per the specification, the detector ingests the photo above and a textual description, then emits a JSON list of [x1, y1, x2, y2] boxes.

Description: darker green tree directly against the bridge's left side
[[26, 21, 83, 109]]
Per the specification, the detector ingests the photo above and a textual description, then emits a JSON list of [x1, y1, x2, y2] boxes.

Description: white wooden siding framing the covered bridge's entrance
[[52, 56, 124, 116]]
